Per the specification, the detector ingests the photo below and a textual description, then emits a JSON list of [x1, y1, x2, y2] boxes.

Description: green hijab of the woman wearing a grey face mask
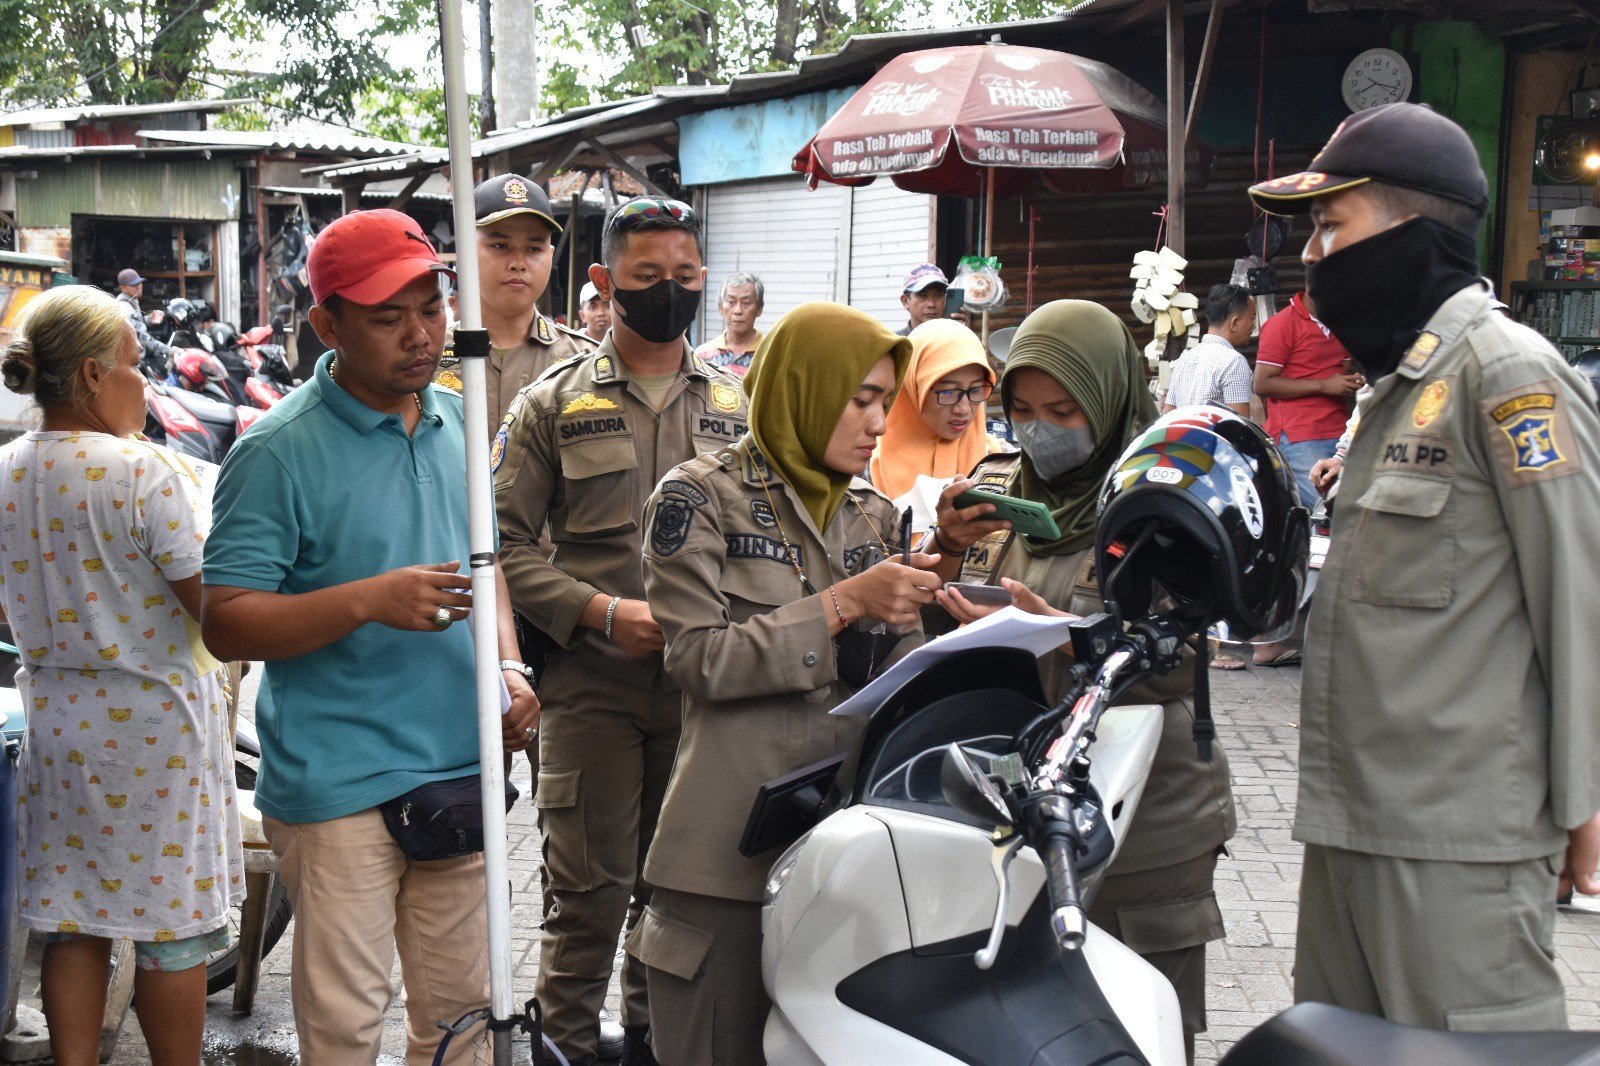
[[1000, 299, 1157, 555]]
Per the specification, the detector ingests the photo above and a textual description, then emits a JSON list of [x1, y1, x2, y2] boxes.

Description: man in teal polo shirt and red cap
[[202, 211, 538, 1066]]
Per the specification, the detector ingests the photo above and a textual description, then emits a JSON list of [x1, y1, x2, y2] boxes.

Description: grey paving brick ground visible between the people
[[72, 667, 1600, 1066]]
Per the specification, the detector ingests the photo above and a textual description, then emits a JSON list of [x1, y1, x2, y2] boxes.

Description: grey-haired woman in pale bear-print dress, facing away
[[0, 285, 243, 1066]]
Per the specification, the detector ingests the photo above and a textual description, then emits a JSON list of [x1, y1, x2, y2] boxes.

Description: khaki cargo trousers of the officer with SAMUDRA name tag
[[534, 651, 683, 1058]]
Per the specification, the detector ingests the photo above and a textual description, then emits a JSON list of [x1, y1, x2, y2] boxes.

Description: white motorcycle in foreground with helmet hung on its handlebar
[[741, 408, 1600, 1066]]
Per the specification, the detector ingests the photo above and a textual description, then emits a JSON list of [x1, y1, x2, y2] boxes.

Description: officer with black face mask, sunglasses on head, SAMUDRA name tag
[[491, 200, 746, 1061]]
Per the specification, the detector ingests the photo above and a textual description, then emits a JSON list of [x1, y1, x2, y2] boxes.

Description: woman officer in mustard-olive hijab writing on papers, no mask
[[627, 303, 939, 1066]]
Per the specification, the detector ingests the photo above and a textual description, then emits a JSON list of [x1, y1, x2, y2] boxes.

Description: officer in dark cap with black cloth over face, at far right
[[1251, 104, 1600, 1031]]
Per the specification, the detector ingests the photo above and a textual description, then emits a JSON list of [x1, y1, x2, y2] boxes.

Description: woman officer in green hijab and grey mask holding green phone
[[928, 299, 1235, 1058]]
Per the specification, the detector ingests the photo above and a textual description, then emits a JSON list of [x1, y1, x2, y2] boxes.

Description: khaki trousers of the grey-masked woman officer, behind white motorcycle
[[1088, 852, 1224, 1061]]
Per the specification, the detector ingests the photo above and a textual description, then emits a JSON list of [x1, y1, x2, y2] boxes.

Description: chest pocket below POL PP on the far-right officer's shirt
[[1350, 474, 1456, 608]]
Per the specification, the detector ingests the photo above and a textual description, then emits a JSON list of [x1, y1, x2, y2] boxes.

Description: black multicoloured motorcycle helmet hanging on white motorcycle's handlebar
[[1094, 407, 1309, 640]]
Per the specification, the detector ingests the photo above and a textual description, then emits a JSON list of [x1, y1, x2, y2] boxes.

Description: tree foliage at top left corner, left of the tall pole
[[0, 0, 434, 122]]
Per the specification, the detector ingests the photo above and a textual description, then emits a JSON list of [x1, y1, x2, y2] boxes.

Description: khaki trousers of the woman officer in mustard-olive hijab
[[627, 888, 773, 1066]]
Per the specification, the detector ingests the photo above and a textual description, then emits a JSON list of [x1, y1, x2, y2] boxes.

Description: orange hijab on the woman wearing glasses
[[872, 319, 995, 499]]
